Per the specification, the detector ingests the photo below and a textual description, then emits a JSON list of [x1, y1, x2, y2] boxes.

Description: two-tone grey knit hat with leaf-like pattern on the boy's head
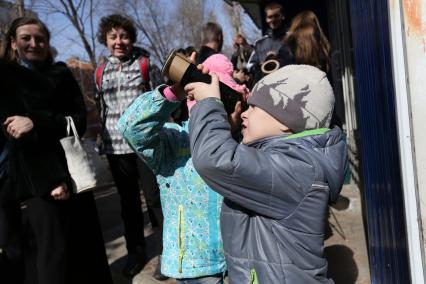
[[248, 65, 334, 133]]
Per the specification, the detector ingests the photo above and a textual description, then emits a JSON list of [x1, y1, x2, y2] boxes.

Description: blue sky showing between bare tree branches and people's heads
[[20, 0, 260, 61]]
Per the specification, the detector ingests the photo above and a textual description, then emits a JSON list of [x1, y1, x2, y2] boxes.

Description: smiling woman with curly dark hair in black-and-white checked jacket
[[96, 15, 164, 279]]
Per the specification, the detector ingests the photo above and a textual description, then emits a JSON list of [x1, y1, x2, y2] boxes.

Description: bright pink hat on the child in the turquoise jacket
[[187, 53, 248, 111]]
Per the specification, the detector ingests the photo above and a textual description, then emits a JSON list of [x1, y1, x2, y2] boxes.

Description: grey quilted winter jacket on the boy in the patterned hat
[[189, 98, 347, 284]]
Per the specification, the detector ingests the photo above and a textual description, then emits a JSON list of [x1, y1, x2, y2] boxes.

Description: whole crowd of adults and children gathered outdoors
[[0, 3, 347, 284]]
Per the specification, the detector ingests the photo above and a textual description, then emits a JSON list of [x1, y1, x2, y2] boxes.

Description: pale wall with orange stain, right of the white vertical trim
[[402, 0, 426, 254]]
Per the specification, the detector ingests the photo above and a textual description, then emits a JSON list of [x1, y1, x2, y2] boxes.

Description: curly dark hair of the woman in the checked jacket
[[98, 14, 138, 45]]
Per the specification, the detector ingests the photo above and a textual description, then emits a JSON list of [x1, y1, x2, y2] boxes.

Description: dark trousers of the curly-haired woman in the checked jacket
[[107, 154, 163, 254]]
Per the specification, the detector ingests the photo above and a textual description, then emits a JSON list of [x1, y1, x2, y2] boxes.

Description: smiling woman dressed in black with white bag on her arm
[[0, 17, 112, 284]]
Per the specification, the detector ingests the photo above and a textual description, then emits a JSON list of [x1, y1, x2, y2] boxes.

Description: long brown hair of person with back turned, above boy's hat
[[284, 11, 331, 72]]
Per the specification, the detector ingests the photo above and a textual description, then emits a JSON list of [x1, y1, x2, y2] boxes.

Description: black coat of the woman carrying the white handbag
[[0, 61, 86, 202]]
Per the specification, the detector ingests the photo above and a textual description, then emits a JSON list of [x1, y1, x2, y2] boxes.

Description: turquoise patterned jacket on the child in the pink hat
[[118, 86, 226, 278]]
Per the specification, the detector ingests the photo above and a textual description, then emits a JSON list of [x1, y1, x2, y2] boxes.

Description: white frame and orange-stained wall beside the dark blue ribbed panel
[[389, 0, 426, 283]]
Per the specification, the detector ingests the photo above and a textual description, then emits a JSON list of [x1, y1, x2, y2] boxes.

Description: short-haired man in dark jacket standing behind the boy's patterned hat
[[247, 2, 287, 84]]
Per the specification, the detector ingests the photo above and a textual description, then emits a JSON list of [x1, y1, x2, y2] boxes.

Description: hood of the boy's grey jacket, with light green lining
[[250, 127, 348, 202]]
